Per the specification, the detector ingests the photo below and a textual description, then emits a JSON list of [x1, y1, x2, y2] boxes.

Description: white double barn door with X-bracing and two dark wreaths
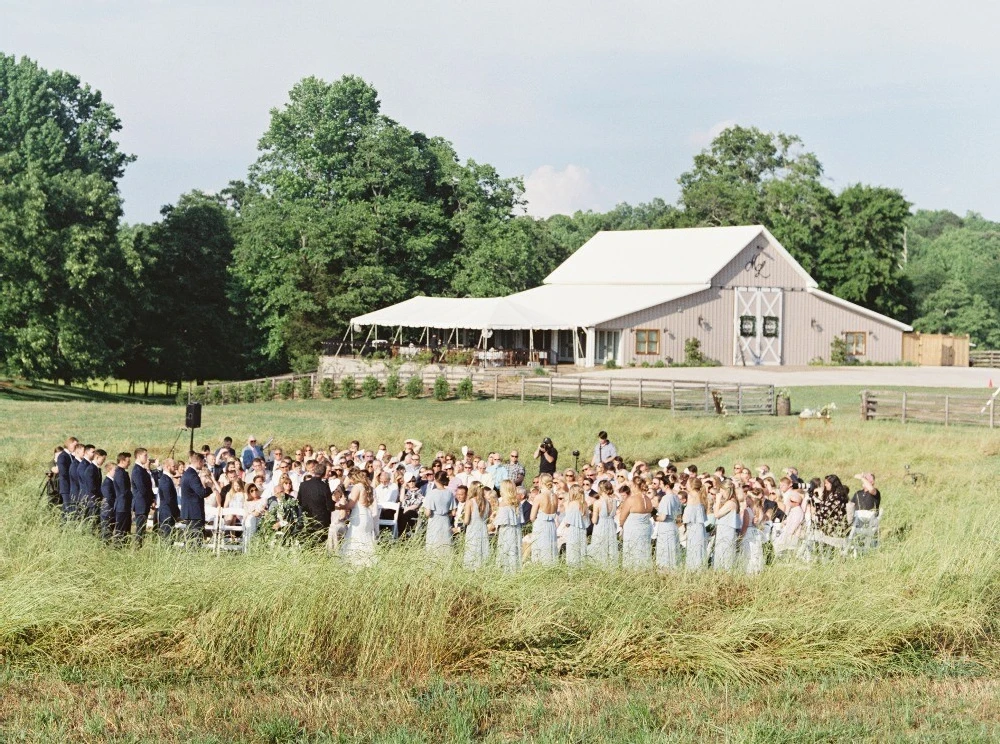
[[733, 287, 785, 366]]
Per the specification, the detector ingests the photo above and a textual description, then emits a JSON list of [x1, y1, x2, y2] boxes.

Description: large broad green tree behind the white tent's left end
[[233, 72, 522, 368]]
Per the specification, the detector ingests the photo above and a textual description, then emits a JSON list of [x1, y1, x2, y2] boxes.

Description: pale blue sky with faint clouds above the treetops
[[0, 0, 1000, 222]]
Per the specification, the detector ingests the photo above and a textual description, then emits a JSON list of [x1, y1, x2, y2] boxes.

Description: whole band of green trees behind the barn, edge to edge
[[0, 55, 1000, 381]]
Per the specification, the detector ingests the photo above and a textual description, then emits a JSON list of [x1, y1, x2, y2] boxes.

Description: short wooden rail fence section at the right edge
[[861, 390, 1000, 429]]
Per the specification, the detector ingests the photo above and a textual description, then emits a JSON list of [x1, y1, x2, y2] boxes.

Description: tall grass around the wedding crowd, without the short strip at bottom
[[0, 401, 1000, 682]]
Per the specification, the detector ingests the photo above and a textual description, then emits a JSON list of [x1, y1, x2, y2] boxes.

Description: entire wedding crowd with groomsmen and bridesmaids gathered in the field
[[49, 431, 881, 574]]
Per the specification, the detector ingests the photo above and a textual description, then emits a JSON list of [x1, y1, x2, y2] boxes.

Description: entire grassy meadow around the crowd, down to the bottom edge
[[0, 400, 1000, 742]]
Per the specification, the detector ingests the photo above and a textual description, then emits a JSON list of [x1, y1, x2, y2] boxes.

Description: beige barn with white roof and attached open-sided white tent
[[352, 225, 912, 367]]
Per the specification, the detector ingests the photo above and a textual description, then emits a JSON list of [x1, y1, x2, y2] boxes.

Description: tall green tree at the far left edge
[[0, 55, 133, 381]]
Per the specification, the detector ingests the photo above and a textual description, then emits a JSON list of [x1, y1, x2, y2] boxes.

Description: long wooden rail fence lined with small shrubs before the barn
[[198, 369, 775, 416]]
